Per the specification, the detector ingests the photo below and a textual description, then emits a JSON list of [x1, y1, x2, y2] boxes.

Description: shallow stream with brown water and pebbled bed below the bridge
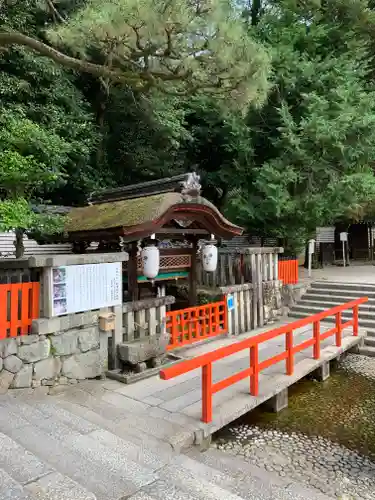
[[213, 355, 375, 500]]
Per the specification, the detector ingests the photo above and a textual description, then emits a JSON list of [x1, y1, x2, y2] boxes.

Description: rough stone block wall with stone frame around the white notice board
[[0, 252, 128, 393]]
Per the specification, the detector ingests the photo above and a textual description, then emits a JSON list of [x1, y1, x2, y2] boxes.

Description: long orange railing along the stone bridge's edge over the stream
[[160, 297, 368, 423]]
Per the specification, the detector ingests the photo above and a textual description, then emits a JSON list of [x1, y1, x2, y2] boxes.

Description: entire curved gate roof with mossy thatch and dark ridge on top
[[65, 173, 242, 241]]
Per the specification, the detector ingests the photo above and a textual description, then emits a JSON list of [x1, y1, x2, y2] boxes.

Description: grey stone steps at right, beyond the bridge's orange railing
[[289, 281, 375, 357]]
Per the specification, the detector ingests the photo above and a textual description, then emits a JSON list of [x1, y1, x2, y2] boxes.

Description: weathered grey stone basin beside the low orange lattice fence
[[117, 335, 169, 365]]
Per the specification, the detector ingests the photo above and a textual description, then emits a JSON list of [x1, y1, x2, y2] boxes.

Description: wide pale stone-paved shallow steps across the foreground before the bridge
[[0, 384, 328, 500]]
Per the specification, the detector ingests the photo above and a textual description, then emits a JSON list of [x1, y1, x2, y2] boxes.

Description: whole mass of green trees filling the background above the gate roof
[[0, 0, 375, 258]]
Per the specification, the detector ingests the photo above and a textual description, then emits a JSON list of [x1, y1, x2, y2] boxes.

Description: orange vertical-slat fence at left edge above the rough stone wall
[[0, 283, 39, 339]]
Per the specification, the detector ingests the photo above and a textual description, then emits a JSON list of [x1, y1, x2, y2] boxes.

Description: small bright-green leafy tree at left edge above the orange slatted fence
[[0, 112, 69, 257]]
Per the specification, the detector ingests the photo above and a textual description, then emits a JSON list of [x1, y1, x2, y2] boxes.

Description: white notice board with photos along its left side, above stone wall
[[51, 262, 122, 316]]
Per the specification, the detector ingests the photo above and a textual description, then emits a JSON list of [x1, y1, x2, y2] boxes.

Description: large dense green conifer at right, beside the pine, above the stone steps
[[230, 2, 375, 251]]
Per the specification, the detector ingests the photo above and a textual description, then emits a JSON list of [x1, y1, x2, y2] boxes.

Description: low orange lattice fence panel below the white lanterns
[[166, 300, 228, 350]]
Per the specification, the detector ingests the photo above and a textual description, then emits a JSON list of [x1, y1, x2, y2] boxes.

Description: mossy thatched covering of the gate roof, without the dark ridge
[[65, 192, 241, 233]]
